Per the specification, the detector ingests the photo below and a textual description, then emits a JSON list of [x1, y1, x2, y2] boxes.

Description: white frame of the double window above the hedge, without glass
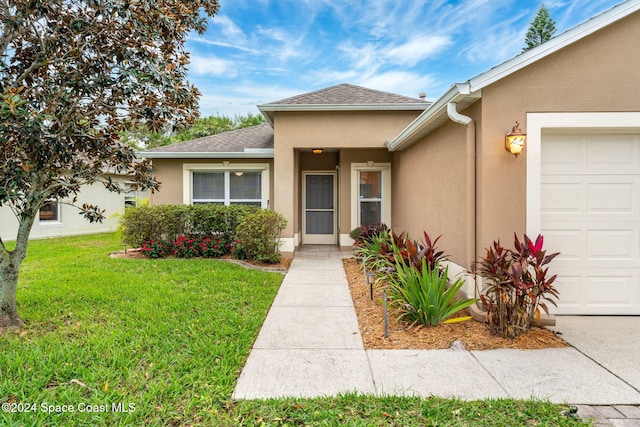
[[182, 162, 269, 209]]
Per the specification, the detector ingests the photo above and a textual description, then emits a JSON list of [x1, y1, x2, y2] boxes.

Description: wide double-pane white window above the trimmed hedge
[[185, 164, 269, 208]]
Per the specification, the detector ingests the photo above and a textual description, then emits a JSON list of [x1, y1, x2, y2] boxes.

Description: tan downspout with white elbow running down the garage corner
[[447, 102, 476, 294]]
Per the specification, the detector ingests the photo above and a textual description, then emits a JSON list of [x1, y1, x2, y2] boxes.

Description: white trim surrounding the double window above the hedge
[[182, 162, 269, 209]]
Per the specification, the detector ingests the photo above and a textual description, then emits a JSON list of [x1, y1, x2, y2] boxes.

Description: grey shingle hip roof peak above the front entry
[[258, 83, 430, 123]]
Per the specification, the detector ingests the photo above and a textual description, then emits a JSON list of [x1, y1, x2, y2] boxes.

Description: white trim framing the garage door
[[525, 112, 640, 236]]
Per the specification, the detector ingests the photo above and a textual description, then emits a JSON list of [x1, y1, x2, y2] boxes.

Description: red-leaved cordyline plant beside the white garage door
[[473, 233, 559, 338]]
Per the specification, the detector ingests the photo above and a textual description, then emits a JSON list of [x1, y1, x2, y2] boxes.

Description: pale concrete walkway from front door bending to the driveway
[[233, 247, 640, 426]]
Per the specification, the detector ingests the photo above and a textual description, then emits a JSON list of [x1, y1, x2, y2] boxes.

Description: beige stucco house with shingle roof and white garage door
[[143, 0, 640, 314]]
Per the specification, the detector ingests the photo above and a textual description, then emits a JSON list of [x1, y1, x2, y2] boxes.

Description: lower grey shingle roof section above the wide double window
[[141, 123, 273, 158]]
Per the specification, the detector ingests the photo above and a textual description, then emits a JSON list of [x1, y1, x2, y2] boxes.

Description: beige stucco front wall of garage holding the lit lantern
[[477, 13, 640, 251]]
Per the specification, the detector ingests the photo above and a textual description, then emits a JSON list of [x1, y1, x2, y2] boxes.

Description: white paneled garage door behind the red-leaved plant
[[541, 131, 640, 314]]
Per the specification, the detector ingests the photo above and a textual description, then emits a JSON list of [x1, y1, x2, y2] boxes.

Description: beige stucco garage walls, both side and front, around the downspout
[[393, 13, 640, 266]]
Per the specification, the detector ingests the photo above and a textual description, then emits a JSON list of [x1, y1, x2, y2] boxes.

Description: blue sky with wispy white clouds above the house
[[187, 0, 622, 117]]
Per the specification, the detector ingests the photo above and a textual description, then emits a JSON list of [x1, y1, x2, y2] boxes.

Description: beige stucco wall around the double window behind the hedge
[[149, 159, 273, 206]]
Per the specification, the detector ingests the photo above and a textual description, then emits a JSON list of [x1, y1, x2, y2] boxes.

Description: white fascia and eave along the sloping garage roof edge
[[387, 0, 640, 151]]
